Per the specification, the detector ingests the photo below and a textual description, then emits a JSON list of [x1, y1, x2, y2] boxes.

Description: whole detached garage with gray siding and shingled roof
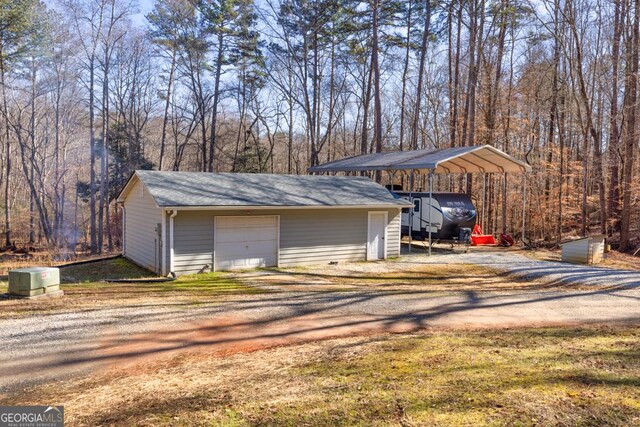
[[118, 171, 409, 275]]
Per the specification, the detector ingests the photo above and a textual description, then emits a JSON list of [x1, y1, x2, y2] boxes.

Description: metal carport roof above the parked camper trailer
[[309, 145, 531, 173]]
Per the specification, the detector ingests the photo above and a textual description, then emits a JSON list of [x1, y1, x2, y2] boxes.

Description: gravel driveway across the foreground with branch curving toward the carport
[[0, 253, 640, 392]]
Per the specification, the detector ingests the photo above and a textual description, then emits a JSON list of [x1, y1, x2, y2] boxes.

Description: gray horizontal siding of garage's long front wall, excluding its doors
[[155, 208, 400, 275]]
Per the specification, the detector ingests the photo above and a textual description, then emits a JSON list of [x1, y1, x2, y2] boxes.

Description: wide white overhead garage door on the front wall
[[213, 216, 278, 271]]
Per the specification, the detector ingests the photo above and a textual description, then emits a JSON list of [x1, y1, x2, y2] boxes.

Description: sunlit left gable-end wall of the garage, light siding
[[123, 181, 161, 273]]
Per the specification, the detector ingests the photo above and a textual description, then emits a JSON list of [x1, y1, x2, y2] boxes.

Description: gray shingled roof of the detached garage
[[129, 171, 408, 207]]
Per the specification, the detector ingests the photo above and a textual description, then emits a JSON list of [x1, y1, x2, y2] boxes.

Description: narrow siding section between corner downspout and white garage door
[[173, 211, 213, 275]]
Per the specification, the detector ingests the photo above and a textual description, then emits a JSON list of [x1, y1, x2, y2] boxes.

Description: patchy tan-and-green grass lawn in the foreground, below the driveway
[[11, 327, 640, 426]]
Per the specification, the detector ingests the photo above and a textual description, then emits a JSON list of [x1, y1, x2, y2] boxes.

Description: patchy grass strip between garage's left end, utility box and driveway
[[0, 258, 266, 319]]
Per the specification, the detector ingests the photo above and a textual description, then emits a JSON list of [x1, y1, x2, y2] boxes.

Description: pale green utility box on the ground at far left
[[9, 267, 62, 297]]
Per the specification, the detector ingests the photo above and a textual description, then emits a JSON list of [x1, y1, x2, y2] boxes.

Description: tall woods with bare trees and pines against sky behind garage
[[0, 0, 640, 253]]
